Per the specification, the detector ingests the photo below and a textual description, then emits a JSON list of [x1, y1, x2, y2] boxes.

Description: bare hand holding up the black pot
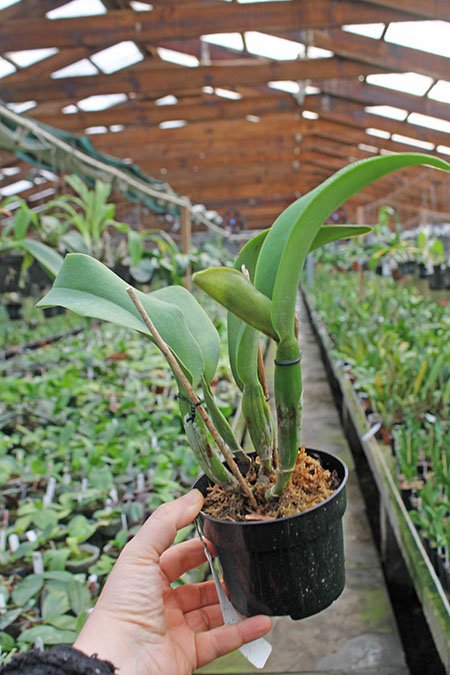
[[74, 490, 272, 675]]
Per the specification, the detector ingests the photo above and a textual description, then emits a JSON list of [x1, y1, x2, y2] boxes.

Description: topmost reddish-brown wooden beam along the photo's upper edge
[[0, 0, 414, 51]]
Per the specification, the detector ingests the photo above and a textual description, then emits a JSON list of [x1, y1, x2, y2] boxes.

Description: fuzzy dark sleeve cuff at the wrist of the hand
[[0, 645, 116, 675]]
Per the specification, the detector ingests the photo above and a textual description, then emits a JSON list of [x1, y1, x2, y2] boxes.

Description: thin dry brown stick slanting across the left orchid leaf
[[127, 286, 258, 509]]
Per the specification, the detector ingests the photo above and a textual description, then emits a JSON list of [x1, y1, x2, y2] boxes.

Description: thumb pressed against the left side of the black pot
[[124, 490, 204, 562]]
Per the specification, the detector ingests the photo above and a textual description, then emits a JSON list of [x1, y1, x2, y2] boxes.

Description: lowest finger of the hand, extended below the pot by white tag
[[195, 616, 272, 667]]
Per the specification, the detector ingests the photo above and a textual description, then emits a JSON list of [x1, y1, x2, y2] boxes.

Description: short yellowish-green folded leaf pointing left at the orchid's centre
[[192, 267, 277, 340]]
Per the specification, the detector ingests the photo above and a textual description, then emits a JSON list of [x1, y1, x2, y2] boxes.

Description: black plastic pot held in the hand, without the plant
[[194, 449, 348, 619]]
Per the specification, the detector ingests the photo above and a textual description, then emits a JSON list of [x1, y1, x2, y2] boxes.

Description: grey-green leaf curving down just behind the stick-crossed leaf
[[152, 286, 220, 382]]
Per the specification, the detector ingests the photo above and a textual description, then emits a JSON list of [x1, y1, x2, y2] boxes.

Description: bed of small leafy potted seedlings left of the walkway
[[0, 317, 236, 659]]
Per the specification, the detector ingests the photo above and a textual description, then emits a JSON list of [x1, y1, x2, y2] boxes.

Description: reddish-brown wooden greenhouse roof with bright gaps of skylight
[[0, 0, 450, 228]]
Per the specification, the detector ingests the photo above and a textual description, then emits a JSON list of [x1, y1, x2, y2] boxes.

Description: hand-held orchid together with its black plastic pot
[[39, 153, 450, 619]]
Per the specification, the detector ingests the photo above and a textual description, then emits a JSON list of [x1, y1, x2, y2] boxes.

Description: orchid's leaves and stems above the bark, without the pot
[[39, 153, 450, 507]]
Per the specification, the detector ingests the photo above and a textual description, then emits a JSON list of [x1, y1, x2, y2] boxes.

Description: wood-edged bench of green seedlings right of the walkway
[[304, 268, 450, 663]]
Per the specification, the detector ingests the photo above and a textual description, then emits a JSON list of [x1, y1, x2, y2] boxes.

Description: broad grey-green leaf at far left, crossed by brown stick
[[38, 253, 205, 386]]
